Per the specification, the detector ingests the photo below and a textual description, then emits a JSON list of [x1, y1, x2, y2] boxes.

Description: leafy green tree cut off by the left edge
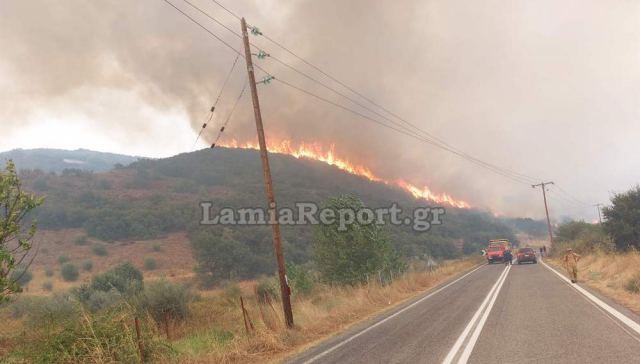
[[0, 160, 44, 302]]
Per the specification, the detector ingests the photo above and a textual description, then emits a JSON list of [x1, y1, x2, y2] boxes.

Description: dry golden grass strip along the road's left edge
[[175, 259, 479, 363]]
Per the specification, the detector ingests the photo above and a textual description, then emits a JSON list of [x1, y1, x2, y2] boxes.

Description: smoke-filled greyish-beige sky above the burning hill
[[0, 0, 640, 221]]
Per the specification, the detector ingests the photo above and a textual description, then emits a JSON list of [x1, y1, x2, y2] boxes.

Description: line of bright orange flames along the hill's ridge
[[218, 139, 471, 209]]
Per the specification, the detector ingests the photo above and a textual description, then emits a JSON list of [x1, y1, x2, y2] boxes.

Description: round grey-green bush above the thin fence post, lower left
[[142, 279, 193, 322]]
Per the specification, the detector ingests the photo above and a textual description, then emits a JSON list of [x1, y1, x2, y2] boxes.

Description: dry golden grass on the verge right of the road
[[553, 251, 640, 313]]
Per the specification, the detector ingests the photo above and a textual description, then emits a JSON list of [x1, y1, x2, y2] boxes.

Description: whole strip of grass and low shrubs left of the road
[[0, 258, 479, 363]]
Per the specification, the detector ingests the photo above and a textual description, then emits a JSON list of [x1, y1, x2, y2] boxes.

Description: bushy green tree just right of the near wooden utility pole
[[314, 195, 406, 284]]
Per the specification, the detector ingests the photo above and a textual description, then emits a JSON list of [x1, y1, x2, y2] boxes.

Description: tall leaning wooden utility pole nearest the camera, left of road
[[240, 18, 293, 327]]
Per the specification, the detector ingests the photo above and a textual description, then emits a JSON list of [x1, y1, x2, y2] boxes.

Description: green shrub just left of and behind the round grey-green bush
[[89, 262, 143, 296]]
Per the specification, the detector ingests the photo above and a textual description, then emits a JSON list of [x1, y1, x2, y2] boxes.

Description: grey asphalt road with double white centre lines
[[289, 258, 640, 363]]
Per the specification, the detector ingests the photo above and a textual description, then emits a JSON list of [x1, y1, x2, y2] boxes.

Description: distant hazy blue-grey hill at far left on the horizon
[[0, 149, 138, 173]]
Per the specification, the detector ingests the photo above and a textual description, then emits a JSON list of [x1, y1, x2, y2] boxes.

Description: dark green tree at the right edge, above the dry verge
[[602, 186, 640, 250]]
